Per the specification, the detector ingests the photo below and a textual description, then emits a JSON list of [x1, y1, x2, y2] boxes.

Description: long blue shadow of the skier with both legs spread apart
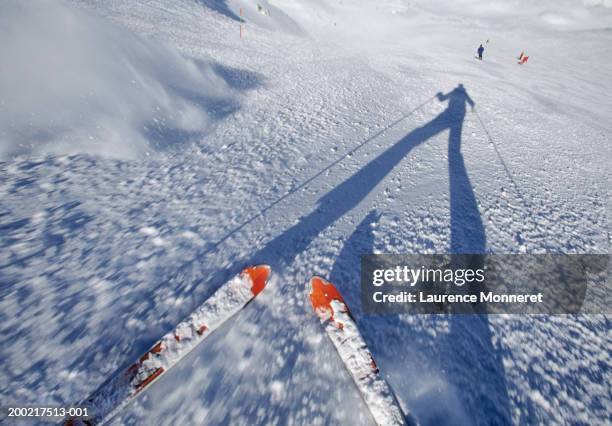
[[253, 84, 511, 424]]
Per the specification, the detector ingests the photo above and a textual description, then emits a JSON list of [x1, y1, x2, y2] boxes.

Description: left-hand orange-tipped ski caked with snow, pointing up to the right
[[64, 265, 270, 425]]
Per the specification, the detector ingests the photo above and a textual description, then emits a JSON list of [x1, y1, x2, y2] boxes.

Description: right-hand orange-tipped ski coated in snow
[[310, 277, 406, 425]]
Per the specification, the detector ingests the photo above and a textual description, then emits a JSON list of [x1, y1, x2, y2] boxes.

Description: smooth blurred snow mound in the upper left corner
[[0, 0, 235, 159]]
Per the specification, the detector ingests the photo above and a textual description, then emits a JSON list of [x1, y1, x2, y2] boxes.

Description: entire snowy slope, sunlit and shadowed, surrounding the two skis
[[0, 0, 612, 425]]
